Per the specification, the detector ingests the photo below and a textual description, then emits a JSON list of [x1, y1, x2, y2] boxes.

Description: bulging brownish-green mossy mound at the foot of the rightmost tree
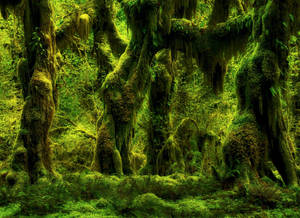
[[223, 113, 267, 184]]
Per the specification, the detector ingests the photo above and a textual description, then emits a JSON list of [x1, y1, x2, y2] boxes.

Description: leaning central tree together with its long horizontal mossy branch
[[93, 0, 251, 174]]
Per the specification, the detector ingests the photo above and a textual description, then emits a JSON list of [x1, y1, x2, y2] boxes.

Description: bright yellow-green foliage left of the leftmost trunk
[[0, 17, 23, 166]]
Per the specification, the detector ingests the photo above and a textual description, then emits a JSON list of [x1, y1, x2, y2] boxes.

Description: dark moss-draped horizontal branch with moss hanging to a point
[[170, 15, 252, 94]]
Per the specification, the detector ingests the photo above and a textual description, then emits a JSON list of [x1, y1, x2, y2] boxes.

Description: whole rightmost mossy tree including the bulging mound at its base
[[224, 0, 299, 185]]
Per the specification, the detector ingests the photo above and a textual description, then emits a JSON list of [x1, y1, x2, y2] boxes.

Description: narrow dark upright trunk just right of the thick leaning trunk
[[143, 49, 174, 174]]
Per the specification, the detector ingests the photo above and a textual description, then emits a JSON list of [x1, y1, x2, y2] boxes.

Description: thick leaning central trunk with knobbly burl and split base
[[93, 1, 158, 175]]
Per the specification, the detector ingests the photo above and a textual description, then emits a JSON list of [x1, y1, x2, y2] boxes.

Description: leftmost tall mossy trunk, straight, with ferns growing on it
[[12, 0, 57, 183]]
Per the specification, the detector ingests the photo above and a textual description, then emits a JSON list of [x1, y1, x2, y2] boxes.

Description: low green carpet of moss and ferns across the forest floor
[[0, 171, 300, 217]]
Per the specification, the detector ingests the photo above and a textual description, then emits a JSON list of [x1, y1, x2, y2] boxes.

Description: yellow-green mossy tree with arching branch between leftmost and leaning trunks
[[56, 0, 127, 84]]
